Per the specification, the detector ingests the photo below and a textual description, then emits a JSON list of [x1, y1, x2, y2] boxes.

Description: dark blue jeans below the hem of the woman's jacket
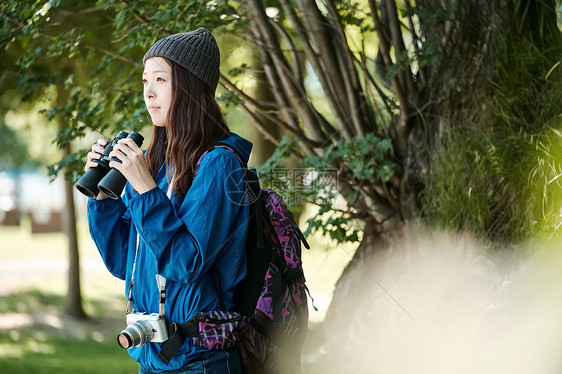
[[139, 348, 242, 374]]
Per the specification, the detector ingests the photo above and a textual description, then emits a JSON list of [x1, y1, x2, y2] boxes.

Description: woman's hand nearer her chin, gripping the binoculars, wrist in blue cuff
[[109, 138, 156, 194]]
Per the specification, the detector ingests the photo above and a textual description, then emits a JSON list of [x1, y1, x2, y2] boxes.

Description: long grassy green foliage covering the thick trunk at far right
[[424, 21, 562, 241]]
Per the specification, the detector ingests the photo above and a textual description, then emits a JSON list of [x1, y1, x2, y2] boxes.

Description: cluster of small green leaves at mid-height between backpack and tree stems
[[257, 134, 384, 243]]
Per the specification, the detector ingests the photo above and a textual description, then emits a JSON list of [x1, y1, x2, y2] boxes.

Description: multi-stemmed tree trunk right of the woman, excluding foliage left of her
[[232, 0, 562, 342]]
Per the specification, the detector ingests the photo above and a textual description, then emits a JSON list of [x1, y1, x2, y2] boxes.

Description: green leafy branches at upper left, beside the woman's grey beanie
[[0, 0, 245, 180]]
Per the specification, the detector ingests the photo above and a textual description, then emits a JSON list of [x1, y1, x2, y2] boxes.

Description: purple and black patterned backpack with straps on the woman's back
[[158, 143, 310, 374]]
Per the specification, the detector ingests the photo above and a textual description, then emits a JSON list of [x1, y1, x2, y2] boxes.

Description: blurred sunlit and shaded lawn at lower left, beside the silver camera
[[0, 290, 138, 374]]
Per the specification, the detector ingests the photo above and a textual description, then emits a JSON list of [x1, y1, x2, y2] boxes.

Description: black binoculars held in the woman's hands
[[75, 131, 144, 199]]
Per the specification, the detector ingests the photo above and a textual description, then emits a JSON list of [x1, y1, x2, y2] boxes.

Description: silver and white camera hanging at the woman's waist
[[117, 312, 168, 349]]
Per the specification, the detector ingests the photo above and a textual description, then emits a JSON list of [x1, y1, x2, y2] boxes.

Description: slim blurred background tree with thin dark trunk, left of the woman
[[1, 2, 115, 319]]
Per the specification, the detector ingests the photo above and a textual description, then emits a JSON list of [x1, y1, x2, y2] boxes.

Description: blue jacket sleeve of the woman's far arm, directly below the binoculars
[[88, 198, 131, 279]]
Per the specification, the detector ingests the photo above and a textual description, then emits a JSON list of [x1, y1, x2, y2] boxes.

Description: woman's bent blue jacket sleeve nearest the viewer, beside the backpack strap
[[129, 149, 247, 283]]
